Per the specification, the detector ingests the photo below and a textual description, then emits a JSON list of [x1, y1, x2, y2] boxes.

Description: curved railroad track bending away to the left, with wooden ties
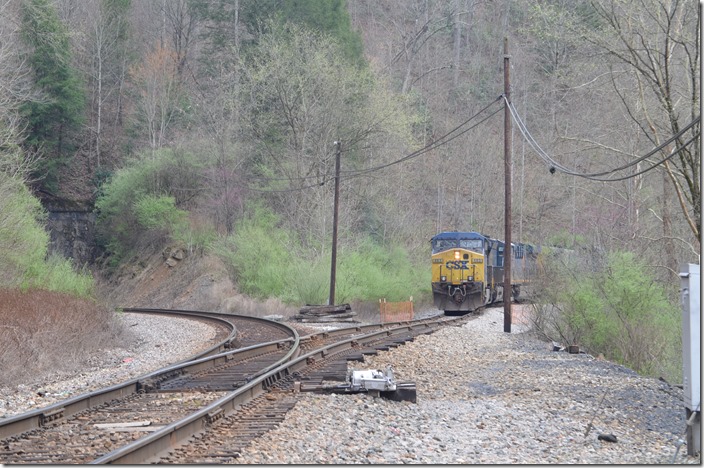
[[0, 309, 299, 464]]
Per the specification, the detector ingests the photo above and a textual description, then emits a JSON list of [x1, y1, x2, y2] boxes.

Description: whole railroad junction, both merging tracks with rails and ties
[[0, 309, 466, 464]]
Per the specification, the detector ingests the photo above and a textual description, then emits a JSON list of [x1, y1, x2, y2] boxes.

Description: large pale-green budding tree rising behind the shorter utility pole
[[240, 23, 410, 253]]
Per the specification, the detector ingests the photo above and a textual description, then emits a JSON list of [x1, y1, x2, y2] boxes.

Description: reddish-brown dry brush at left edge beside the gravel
[[0, 289, 126, 386]]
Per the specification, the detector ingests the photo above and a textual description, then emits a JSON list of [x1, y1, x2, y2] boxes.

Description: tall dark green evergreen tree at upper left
[[21, 0, 85, 189]]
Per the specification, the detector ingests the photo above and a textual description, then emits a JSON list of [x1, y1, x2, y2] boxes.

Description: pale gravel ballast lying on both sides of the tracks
[[0, 308, 700, 464]]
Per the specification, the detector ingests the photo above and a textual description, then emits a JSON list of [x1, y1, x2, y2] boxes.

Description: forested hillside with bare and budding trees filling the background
[[0, 0, 701, 380]]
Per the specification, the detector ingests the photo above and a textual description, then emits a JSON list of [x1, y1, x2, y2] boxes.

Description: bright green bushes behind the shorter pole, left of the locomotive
[[213, 205, 430, 305]]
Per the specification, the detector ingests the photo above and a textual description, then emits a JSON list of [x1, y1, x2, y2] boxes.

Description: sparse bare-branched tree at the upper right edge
[[584, 0, 701, 250]]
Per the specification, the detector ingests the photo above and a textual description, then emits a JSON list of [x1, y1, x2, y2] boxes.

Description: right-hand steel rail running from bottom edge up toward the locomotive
[[90, 316, 468, 464]]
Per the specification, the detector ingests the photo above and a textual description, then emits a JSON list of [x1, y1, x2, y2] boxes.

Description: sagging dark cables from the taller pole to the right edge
[[502, 95, 700, 182]]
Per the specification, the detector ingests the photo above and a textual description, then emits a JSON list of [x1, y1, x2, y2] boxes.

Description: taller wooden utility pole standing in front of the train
[[504, 37, 512, 333]]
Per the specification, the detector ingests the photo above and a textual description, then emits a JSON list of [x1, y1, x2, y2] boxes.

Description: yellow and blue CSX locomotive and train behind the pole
[[430, 231, 540, 315]]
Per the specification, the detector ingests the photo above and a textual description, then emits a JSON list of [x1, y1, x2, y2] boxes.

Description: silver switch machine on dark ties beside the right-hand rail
[[294, 366, 416, 403]]
